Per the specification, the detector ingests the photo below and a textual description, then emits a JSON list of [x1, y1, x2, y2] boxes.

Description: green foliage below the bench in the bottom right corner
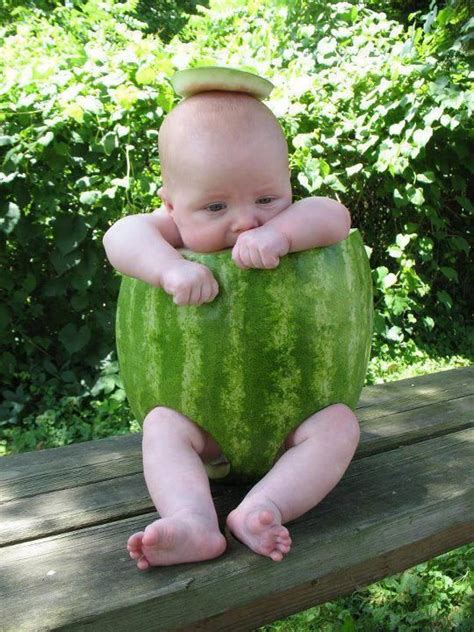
[[259, 545, 474, 632]]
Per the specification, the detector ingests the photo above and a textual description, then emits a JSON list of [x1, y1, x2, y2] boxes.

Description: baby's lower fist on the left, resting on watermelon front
[[161, 259, 219, 305]]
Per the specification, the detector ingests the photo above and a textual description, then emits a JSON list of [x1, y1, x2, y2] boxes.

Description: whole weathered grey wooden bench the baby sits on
[[0, 367, 474, 632]]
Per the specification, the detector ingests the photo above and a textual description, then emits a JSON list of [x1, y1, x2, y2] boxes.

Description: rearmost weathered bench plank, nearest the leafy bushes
[[0, 367, 474, 502]]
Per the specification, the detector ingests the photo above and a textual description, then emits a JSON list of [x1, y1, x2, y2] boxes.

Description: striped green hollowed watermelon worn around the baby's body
[[116, 230, 373, 482]]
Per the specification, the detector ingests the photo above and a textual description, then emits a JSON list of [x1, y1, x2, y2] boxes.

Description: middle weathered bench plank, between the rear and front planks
[[0, 388, 474, 546]]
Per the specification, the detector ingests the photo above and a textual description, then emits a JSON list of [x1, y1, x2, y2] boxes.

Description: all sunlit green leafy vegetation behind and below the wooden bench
[[0, 0, 474, 630]]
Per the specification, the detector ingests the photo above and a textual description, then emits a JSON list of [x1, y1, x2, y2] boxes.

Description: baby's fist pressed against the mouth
[[232, 224, 290, 268]]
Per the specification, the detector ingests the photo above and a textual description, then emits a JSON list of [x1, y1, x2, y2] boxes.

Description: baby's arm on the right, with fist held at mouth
[[232, 197, 351, 268]]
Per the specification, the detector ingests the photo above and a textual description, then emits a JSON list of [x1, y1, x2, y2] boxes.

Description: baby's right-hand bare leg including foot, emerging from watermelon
[[227, 404, 359, 562]]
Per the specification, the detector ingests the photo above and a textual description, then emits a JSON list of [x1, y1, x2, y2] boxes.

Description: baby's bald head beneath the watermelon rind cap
[[159, 91, 292, 252]]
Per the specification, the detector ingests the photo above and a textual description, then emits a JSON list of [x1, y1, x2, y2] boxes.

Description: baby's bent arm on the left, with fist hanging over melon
[[103, 209, 219, 305]]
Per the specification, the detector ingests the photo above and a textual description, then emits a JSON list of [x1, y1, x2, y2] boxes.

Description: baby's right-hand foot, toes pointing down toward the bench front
[[227, 499, 291, 562]]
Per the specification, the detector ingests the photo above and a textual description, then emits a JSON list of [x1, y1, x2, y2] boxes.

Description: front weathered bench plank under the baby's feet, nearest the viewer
[[0, 430, 474, 632]]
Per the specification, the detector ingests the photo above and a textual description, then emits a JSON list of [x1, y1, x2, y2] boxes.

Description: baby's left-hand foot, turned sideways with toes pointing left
[[127, 514, 226, 570]]
